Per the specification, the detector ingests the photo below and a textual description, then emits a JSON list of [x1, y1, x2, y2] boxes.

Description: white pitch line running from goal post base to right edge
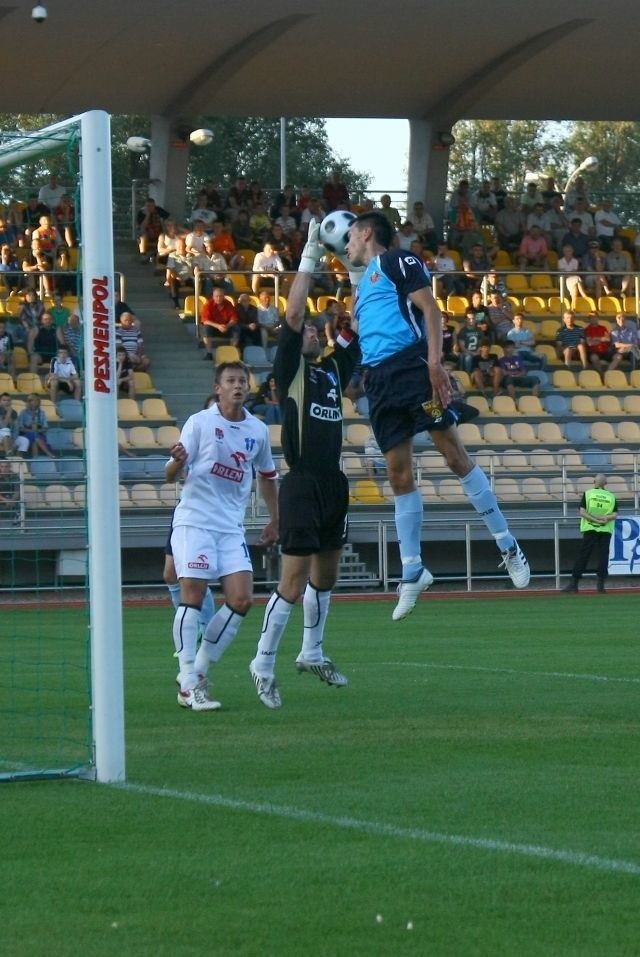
[[119, 783, 640, 877]]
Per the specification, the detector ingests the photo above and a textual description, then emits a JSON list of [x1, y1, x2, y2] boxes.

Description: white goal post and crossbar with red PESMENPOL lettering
[[0, 110, 125, 782]]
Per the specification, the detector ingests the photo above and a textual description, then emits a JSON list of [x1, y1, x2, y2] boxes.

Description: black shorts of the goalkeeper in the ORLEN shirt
[[278, 469, 349, 555]]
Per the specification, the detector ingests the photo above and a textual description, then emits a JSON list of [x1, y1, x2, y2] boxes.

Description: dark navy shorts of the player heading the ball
[[364, 342, 457, 452]]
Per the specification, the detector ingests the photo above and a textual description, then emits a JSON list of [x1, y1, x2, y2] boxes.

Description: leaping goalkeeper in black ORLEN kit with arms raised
[[249, 222, 360, 708]]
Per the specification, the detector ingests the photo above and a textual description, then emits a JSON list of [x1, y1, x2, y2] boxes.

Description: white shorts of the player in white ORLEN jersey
[[171, 525, 253, 581]]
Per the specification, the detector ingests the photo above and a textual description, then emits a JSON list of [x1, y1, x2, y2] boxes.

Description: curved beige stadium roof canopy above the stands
[[0, 0, 640, 129]]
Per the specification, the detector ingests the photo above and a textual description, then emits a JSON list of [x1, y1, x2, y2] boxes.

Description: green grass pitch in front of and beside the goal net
[[0, 594, 640, 957]]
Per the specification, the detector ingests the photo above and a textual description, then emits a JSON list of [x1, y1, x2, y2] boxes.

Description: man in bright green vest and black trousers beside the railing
[[563, 472, 618, 592]]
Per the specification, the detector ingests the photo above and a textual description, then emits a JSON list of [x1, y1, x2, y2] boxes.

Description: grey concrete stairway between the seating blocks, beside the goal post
[[115, 240, 222, 426]]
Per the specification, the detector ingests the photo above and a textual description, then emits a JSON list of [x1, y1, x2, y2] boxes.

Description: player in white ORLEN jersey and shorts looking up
[[166, 362, 278, 711]]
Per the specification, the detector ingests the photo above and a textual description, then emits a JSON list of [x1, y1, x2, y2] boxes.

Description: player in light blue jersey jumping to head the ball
[[347, 212, 530, 621]]
